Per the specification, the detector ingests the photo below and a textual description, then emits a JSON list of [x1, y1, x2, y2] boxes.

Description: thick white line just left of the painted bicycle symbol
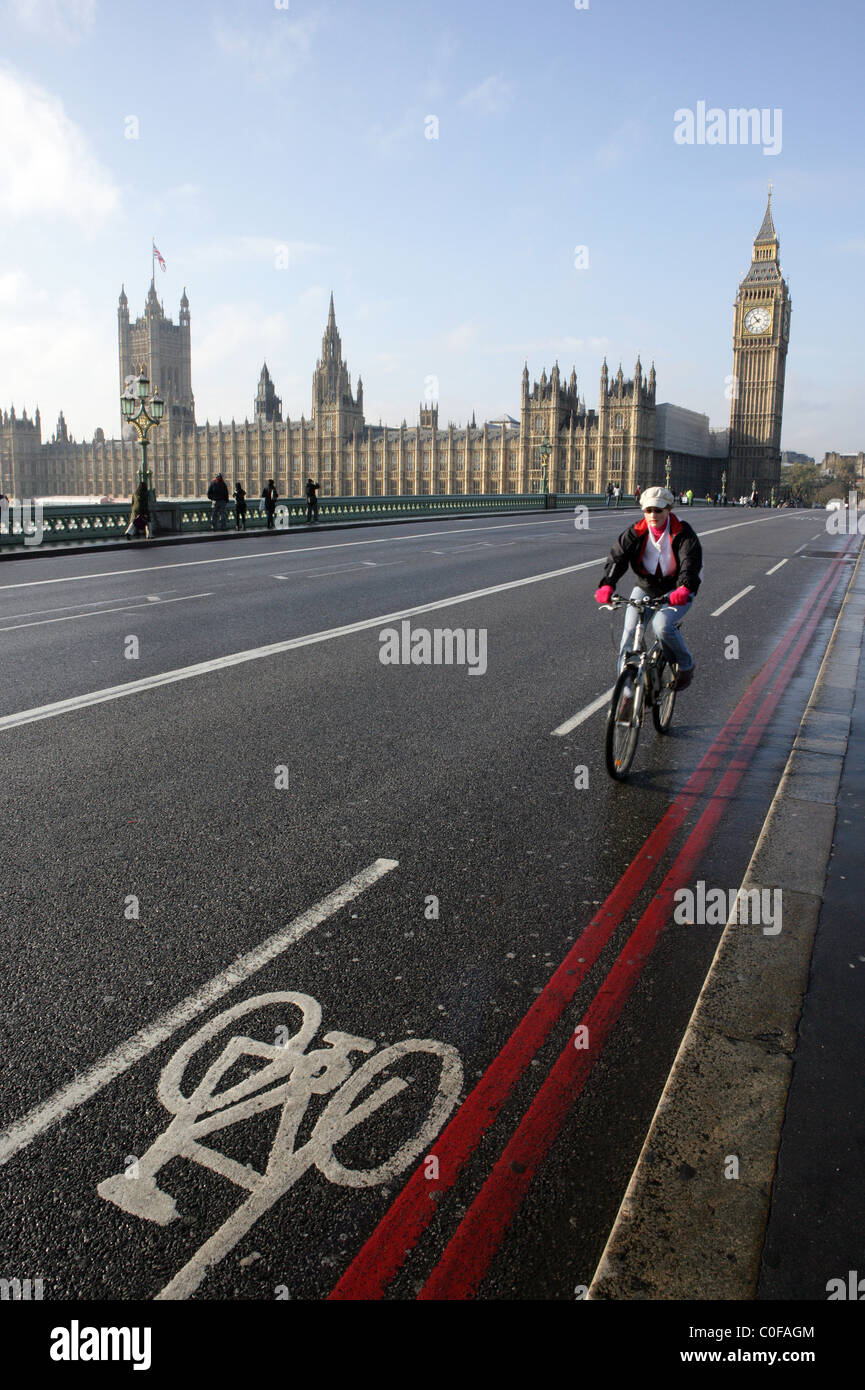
[[0, 859, 399, 1163]]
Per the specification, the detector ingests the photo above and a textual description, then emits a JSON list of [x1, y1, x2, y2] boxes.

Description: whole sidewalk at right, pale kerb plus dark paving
[[588, 536, 865, 1301]]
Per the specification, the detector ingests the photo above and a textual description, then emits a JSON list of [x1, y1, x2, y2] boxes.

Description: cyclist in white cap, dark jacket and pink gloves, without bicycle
[[595, 488, 702, 691]]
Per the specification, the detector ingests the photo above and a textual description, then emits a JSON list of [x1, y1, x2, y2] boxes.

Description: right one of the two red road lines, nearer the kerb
[[419, 544, 862, 1300]]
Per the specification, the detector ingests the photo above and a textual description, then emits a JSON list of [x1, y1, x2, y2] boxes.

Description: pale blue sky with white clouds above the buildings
[[0, 0, 865, 459]]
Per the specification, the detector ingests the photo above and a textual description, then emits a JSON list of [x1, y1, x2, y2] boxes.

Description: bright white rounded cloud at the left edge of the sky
[[0, 67, 120, 229]]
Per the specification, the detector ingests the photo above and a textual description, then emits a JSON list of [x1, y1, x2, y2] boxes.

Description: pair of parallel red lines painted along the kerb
[[330, 542, 852, 1300]]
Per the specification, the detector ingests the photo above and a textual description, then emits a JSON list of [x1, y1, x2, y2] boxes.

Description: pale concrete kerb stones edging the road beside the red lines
[[588, 536, 865, 1300]]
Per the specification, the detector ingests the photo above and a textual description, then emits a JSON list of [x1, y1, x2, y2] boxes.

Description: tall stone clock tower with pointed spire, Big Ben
[[727, 185, 790, 498]]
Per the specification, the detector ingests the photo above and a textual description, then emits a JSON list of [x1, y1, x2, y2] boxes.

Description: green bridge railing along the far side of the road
[[0, 492, 706, 549]]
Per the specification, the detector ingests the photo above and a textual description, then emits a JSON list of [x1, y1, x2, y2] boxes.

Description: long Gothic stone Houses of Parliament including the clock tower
[[0, 193, 790, 498]]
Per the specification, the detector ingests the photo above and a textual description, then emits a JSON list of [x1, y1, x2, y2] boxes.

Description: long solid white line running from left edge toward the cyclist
[[0, 557, 602, 731]]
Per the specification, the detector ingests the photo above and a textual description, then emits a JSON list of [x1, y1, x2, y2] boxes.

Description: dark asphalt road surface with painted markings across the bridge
[[0, 509, 848, 1300]]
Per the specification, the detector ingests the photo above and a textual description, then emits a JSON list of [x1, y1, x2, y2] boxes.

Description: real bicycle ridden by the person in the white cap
[[601, 594, 676, 781]]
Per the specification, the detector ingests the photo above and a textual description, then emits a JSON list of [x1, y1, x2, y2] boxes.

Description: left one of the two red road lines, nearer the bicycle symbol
[[328, 544, 856, 1300]]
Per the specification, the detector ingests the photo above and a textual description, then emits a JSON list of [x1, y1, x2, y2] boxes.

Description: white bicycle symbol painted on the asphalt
[[97, 991, 463, 1298]]
